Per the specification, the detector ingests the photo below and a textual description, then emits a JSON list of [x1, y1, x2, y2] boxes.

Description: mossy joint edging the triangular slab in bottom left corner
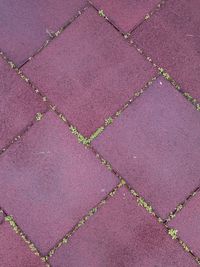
[[0, 207, 50, 267]]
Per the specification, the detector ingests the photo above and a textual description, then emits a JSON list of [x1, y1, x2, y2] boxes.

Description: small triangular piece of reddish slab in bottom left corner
[[0, 223, 46, 267]]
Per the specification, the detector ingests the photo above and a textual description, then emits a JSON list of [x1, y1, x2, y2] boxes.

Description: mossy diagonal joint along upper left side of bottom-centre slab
[[45, 179, 125, 260]]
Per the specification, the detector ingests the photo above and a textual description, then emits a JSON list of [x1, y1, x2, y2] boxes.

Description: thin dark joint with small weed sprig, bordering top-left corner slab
[[18, 4, 88, 69]]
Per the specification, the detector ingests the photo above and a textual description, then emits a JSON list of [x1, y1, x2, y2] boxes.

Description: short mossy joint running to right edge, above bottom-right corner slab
[[164, 186, 200, 224]]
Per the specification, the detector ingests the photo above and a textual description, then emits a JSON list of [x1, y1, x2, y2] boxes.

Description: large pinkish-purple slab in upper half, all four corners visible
[[23, 8, 155, 136]]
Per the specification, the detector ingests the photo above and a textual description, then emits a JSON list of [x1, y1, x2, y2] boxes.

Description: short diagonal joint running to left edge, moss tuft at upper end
[[0, 109, 49, 156]]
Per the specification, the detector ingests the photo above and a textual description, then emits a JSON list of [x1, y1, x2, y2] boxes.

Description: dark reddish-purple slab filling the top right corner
[[133, 0, 200, 100]]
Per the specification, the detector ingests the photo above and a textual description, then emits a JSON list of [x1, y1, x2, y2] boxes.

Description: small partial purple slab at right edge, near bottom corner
[[169, 193, 200, 256]]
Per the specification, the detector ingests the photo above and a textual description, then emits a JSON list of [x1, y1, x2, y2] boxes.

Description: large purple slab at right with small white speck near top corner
[[93, 78, 200, 217]]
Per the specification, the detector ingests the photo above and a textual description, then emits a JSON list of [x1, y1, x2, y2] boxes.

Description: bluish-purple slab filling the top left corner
[[0, 0, 87, 65]]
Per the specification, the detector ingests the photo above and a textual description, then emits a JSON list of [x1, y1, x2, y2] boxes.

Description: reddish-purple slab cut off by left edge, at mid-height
[[0, 58, 47, 149]]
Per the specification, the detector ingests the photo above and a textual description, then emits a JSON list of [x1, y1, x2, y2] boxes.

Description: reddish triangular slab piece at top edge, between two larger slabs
[[91, 0, 159, 32]]
